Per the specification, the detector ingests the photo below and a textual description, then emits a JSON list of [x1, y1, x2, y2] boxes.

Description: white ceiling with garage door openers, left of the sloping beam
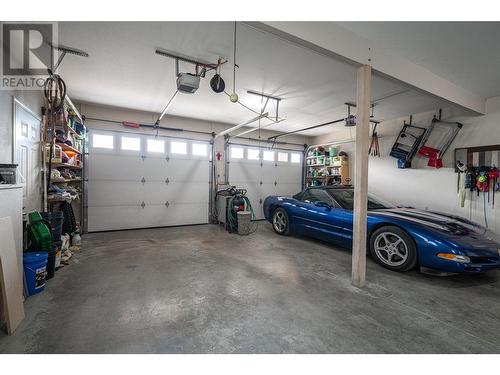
[[59, 22, 456, 135]]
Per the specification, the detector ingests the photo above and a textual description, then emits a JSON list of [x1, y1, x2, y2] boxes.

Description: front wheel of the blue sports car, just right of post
[[370, 226, 417, 272]]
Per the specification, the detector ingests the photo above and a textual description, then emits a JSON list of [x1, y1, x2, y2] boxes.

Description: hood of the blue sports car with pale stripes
[[369, 208, 500, 252]]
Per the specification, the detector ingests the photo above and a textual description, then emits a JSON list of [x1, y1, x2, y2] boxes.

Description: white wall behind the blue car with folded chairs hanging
[[314, 97, 500, 233]]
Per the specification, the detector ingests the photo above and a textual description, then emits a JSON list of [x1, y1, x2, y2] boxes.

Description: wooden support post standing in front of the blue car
[[352, 65, 372, 288]]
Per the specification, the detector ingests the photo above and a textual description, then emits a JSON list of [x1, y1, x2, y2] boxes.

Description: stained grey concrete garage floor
[[0, 222, 500, 353]]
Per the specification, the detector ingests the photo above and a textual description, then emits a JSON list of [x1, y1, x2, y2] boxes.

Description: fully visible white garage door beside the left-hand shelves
[[87, 130, 211, 232]]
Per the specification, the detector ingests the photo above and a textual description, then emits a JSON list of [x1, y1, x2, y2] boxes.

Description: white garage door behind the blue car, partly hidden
[[228, 144, 302, 219]]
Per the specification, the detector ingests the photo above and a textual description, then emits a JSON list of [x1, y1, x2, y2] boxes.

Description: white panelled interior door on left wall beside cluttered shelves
[[13, 99, 42, 212]]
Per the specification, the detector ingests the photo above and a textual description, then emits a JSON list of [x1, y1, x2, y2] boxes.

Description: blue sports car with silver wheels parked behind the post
[[264, 186, 500, 274]]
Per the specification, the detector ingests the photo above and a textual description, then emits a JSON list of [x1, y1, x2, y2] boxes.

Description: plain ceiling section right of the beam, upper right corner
[[337, 22, 500, 98]]
